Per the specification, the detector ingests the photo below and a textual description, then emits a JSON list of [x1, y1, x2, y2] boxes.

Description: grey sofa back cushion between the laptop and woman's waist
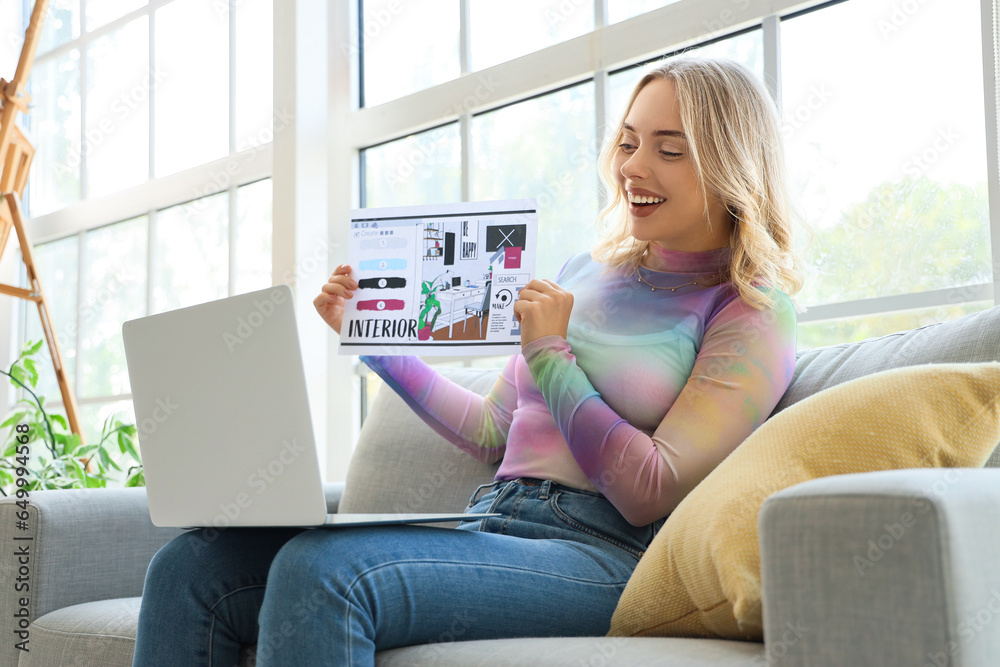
[[339, 368, 500, 512]]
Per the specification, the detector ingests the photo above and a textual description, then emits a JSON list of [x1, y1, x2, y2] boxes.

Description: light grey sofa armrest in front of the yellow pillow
[[760, 468, 1000, 667]]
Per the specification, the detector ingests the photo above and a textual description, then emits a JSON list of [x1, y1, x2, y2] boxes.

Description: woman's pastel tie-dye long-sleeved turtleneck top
[[363, 248, 796, 526]]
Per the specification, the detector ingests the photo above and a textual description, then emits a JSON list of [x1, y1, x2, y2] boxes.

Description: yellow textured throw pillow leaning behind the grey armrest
[[609, 363, 1000, 641]]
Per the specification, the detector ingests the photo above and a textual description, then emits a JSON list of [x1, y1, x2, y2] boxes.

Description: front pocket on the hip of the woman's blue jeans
[[549, 491, 655, 560]]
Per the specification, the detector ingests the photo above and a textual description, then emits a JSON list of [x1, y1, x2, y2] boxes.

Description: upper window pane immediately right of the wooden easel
[[28, 49, 82, 216]]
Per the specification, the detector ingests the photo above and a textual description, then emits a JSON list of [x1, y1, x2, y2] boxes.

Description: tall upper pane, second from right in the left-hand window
[[153, 0, 229, 176]]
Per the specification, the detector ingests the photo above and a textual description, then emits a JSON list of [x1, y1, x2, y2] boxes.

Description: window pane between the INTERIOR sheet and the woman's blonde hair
[[472, 82, 598, 278]]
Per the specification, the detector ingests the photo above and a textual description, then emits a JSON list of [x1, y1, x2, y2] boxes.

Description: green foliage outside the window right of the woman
[[796, 177, 993, 349]]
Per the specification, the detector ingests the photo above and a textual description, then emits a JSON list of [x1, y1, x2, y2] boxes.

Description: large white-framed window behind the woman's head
[[354, 0, 1000, 360]]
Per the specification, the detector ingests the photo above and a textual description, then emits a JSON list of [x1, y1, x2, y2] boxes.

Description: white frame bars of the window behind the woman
[[342, 0, 1000, 332]]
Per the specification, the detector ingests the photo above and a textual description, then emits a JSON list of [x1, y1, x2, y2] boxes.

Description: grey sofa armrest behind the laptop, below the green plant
[[0, 488, 183, 665]]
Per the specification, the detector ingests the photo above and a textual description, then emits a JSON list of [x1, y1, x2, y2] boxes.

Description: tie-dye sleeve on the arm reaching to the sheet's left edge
[[361, 356, 517, 463]]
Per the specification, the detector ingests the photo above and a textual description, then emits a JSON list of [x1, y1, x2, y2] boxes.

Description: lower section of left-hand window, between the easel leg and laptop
[[20, 180, 271, 448]]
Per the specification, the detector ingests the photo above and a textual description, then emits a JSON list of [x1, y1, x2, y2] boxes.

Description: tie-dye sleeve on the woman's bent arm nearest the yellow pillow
[[522, 292, 796, 526]]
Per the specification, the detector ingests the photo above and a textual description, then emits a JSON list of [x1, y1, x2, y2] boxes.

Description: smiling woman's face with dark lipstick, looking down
[[614, 78, 732, 252]]
